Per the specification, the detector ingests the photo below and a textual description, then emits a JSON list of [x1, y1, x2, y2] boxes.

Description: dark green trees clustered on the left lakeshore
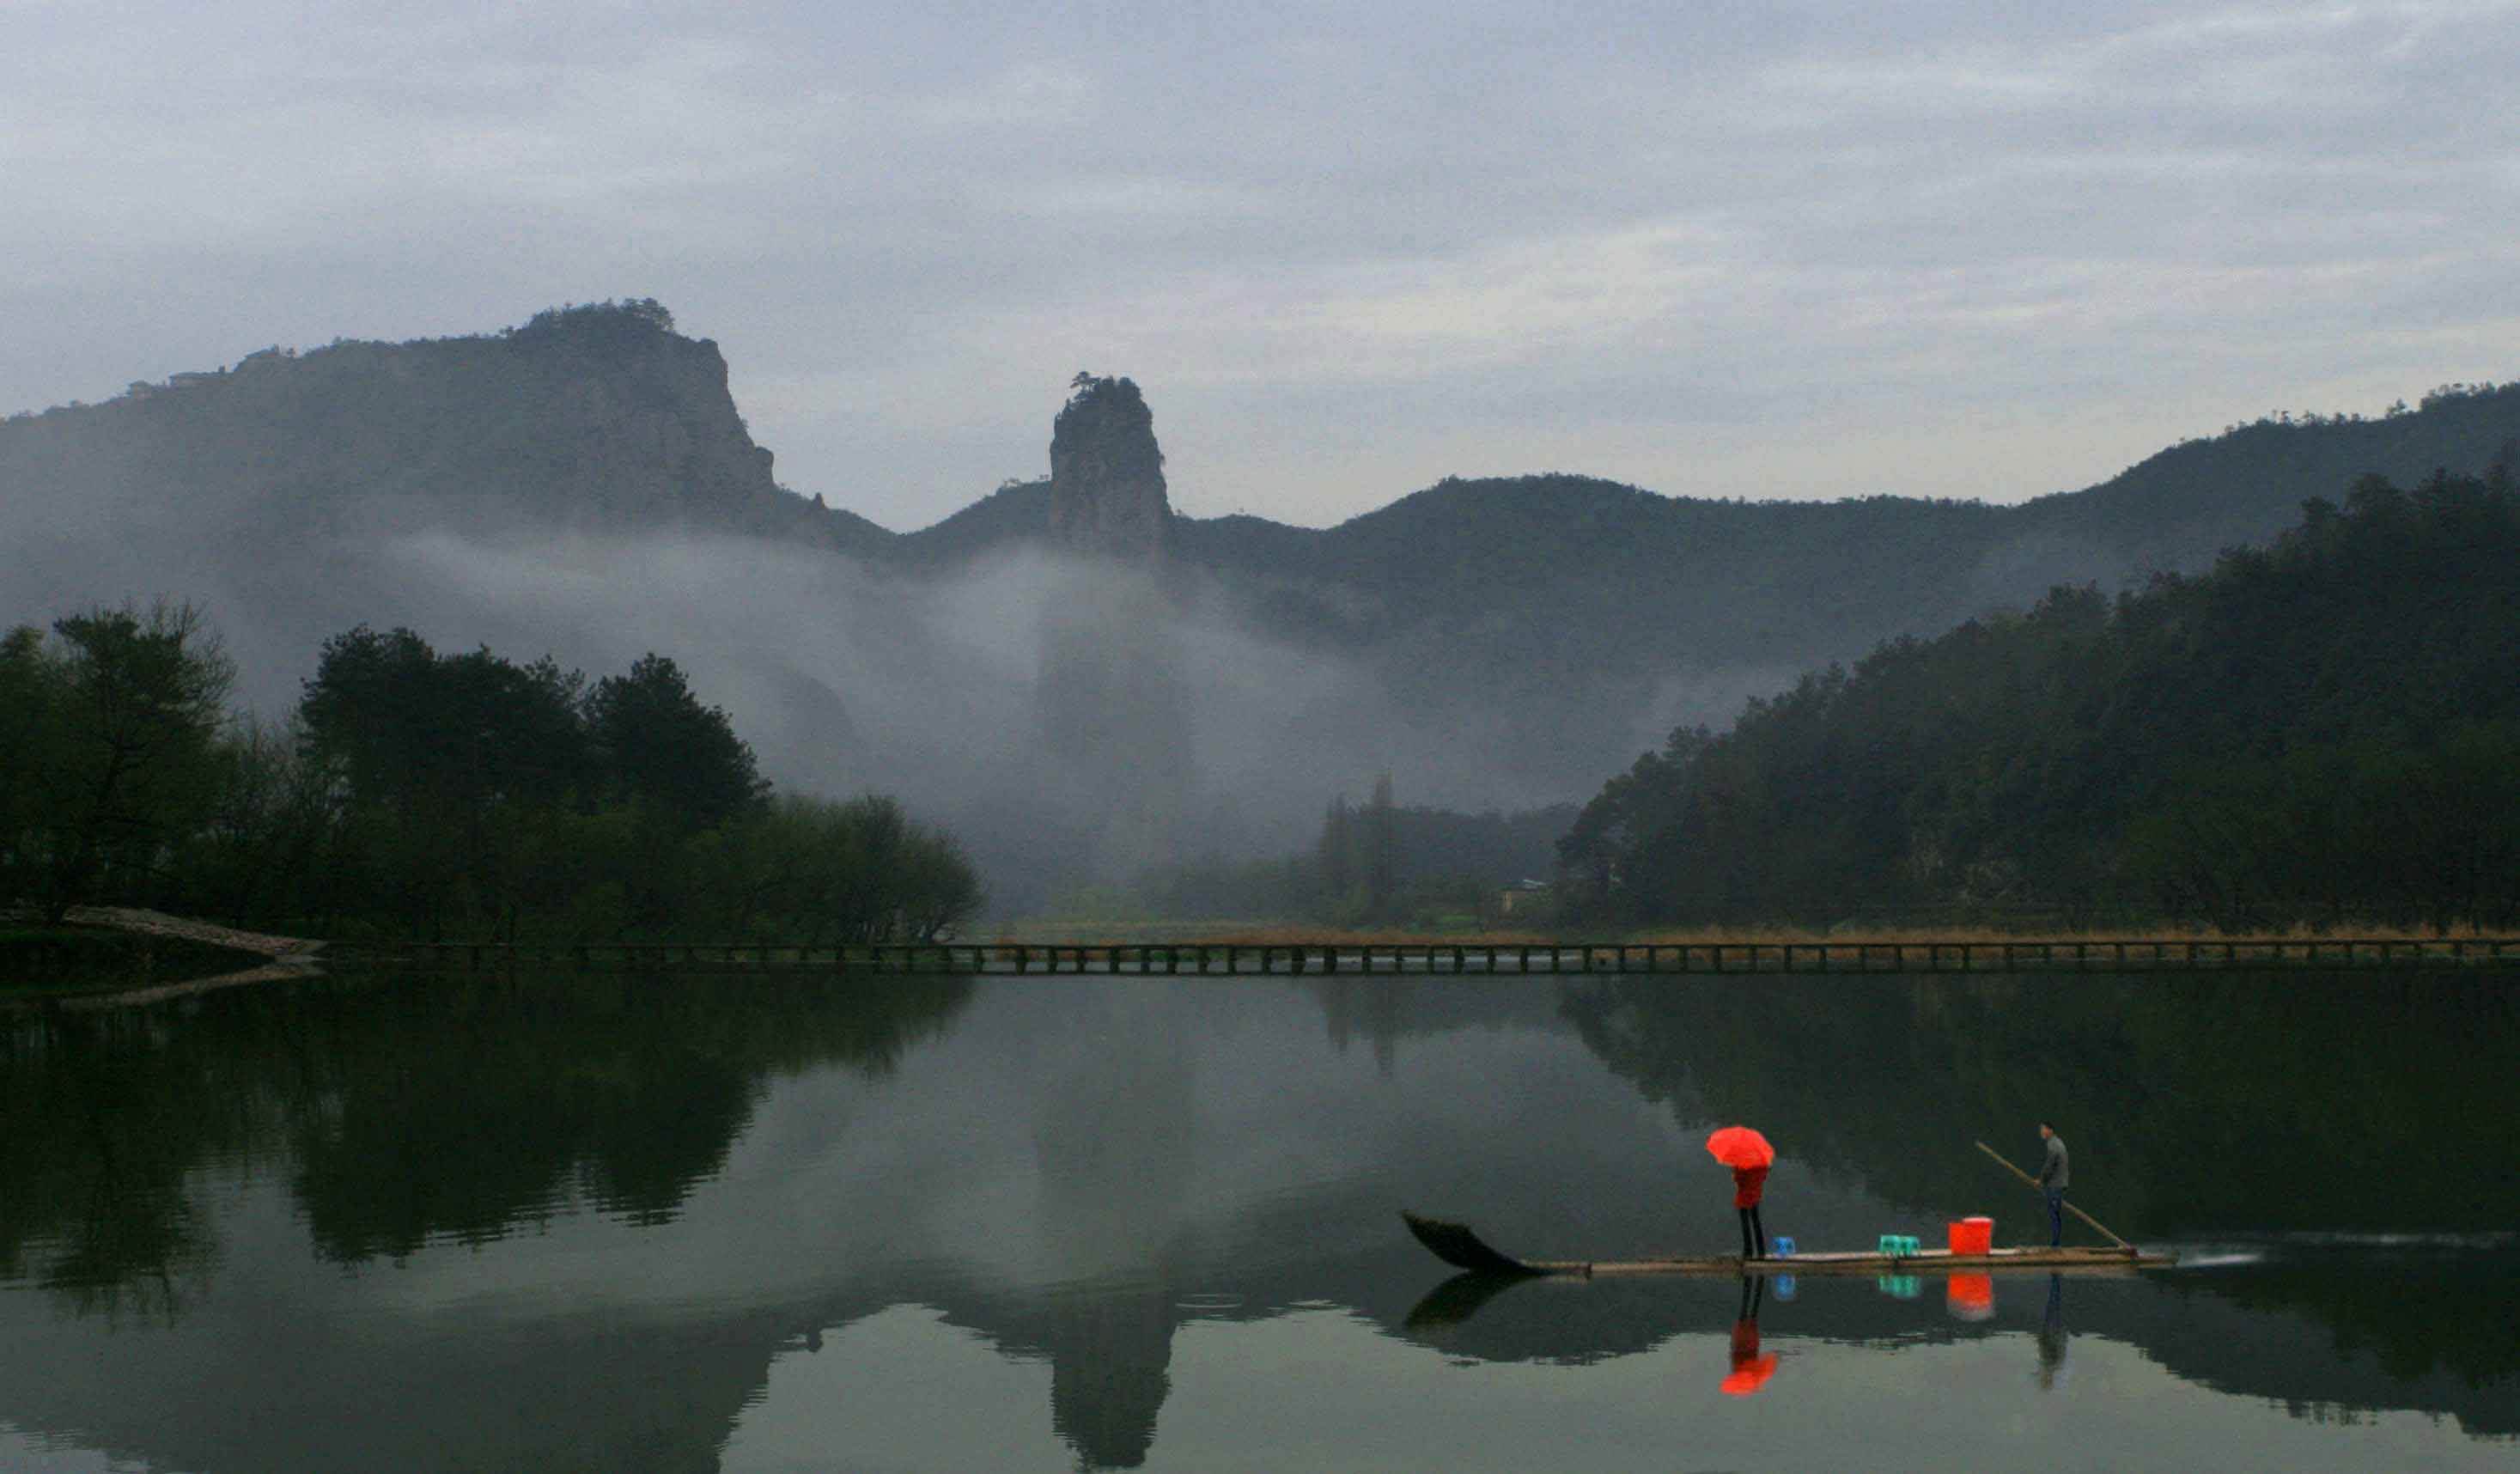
[[0, 602, 983, 945]]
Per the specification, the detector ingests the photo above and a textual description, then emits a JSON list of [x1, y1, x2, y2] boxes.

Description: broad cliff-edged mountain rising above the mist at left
[[0, 302, 890, 549]]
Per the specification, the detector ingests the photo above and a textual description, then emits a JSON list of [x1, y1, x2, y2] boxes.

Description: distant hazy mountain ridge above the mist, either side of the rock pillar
[[0, 300, 2520, 804]]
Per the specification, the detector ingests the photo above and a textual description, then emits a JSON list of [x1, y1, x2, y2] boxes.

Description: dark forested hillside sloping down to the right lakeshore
[[1560, 472, 2520, 927]]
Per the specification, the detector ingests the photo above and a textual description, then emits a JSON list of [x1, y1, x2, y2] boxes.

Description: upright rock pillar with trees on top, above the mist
[[1050, 373, 1172, 562]]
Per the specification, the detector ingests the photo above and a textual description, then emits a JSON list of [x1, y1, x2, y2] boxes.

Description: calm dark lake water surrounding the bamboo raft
[[0, 978, 2520, 1474]]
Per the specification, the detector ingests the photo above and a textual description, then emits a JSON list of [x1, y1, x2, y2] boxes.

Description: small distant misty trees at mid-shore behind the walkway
[[1136, 774, 1575, 927]]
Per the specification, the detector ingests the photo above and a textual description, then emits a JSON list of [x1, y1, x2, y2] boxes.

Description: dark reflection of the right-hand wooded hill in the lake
[[1567, 975, 2520, 1242]]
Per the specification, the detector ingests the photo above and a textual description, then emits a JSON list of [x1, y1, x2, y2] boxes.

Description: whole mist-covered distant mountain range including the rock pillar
[[0, 302, 2520, 899]]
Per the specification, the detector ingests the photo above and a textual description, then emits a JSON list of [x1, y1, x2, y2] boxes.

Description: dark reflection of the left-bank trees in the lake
[[0, 978, 971, 1320]]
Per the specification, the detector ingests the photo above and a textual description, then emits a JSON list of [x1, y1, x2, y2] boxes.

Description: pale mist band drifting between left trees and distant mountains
[[0, 484, 1784, 915]]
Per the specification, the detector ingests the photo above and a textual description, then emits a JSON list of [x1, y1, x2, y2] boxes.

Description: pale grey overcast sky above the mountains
[[0, 0, 2520, 529]]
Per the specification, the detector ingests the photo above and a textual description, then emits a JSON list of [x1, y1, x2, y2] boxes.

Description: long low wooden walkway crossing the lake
[[325, 937, 2520, 978]]
